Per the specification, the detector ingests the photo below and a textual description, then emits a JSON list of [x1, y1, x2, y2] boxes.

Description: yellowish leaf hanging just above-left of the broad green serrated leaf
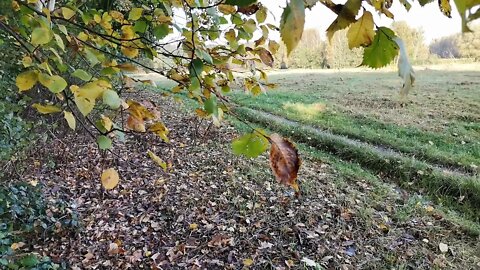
[[347, 11, 375, 49]]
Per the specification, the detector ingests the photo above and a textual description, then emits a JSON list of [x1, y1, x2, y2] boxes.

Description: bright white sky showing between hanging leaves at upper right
[[260, 0, 462, 44]]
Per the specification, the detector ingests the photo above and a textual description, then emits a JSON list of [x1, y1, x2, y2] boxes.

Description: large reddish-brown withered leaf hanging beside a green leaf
[[270, 133, 301, 194]]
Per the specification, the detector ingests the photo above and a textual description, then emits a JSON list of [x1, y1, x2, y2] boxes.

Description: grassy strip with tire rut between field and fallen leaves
[[235, 108, 480, 222]]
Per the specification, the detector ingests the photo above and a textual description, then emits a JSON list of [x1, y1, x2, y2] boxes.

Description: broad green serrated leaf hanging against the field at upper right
[[361, 27, 398, 68]]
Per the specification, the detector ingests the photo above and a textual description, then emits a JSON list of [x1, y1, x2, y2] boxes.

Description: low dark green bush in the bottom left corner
[[0, 183, 78, 269]]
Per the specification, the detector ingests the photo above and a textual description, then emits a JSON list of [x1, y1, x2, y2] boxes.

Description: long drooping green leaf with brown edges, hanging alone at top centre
[[280, 0, 305, 56]]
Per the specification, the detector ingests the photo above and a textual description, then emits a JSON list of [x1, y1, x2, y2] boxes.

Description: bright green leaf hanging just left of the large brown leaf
[[232, 132, 269, 158]]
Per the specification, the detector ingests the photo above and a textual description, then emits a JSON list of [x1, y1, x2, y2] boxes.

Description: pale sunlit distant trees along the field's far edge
[[275, 22, 480, 69]]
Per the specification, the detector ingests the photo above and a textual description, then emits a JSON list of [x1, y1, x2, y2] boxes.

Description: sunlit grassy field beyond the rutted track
[[232, 69, 480, 173]]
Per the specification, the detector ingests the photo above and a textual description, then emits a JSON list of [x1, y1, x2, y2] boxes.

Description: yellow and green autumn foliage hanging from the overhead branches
[[0, 0, 480, 189]]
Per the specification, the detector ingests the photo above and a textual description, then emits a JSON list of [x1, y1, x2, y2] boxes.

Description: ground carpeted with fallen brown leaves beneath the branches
[[11, 91, 480, 269]]
